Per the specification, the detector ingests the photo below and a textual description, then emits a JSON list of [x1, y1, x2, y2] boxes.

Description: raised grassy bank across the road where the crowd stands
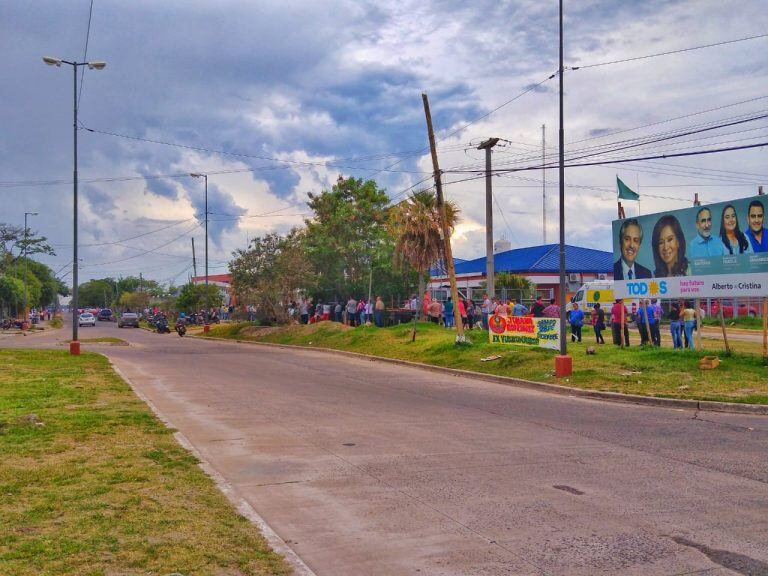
[[202, 322, 768, 404]]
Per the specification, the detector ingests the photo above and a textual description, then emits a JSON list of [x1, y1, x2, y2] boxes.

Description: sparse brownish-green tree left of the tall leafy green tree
[[229, 230, 314, 321]]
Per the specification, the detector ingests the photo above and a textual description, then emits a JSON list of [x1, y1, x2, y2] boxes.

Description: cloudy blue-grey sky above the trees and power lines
[[0, 0, 768, 283]]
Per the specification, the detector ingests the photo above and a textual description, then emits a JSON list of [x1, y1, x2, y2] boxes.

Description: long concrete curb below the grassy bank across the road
[[190, 336, 768, 416]]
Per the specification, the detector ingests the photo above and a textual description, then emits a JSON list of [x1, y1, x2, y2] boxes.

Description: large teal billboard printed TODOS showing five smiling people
[[613, 196, 768, 298]]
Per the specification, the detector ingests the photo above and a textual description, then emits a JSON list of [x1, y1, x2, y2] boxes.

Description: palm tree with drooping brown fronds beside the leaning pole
[[389, 190, 459, 338]]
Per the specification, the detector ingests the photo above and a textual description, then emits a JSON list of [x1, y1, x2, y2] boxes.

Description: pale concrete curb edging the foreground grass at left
[[107, 358, 316, 576]]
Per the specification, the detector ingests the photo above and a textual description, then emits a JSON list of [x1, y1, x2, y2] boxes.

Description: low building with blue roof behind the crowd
[[430, 244, 613, 298]]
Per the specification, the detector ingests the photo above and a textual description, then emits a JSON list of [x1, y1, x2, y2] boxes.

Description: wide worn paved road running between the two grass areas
[[0, 325, 768, 576]]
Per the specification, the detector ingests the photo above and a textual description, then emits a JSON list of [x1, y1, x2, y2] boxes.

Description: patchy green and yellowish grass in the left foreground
[[0, 350, 289, 576]]
